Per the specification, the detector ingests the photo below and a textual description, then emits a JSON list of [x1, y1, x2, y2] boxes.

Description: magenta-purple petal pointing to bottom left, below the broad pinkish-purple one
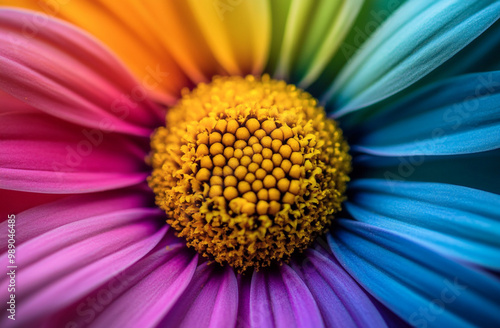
[[84, 242, 198, 328]]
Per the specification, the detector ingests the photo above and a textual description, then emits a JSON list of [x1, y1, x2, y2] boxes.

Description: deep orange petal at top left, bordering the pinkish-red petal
[[2, 0, 189, 102]]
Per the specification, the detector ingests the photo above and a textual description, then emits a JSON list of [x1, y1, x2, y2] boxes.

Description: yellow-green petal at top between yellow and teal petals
[[273, 0, 363, 88]]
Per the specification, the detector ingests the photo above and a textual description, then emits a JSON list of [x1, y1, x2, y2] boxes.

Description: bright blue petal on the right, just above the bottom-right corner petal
[[346, 179, 500, 270]]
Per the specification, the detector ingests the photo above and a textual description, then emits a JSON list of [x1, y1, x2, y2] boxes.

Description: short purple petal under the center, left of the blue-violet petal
[[249, 264, 324, 328]]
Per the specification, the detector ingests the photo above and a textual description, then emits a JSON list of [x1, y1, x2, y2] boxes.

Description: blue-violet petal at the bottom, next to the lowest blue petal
[[292, 249, 387, 327]]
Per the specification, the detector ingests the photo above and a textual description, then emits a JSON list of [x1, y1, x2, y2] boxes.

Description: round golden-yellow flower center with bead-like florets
[[148, 75, 351, 272]]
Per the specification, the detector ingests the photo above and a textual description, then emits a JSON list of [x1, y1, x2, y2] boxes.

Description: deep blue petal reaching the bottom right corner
[[328, 219, 500, 327]]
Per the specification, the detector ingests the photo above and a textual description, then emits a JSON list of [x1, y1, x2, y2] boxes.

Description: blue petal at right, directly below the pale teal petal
[[353, 71, 500, 156]]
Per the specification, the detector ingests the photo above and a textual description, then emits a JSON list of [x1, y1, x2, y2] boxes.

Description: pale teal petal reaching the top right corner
[[324, 0, 500, 116]]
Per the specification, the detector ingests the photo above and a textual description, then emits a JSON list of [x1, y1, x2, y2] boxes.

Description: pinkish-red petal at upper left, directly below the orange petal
[[0, 8, 162, 136]]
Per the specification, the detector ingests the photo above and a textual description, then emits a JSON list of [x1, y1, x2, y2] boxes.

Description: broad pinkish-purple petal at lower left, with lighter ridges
[[0, 209, 167, 326]]
